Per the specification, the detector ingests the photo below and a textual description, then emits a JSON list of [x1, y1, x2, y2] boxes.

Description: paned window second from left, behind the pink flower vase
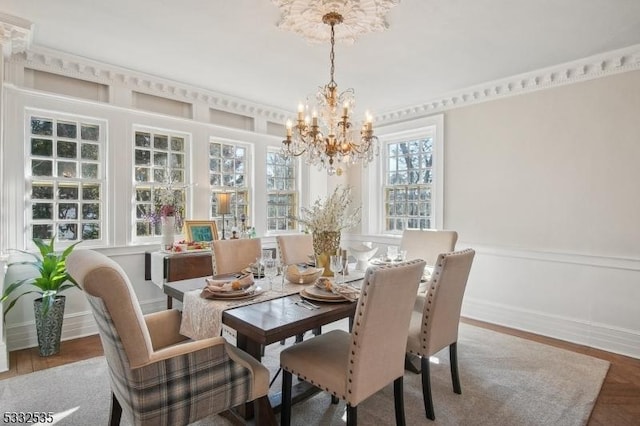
[[133, 129, 187, 237]]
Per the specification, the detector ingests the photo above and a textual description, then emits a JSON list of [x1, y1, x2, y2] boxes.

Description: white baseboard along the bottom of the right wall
[[462, 298, 640, 359]]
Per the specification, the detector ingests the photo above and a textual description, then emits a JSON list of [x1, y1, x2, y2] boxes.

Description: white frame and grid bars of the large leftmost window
[[24, 108, 109, 249]]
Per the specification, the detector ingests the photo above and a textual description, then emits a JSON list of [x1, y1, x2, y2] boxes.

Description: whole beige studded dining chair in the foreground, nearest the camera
[[280, 260, 425, 426]]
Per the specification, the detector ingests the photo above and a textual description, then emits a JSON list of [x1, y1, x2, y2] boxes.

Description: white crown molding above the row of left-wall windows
[[11, 46, 291, 123]]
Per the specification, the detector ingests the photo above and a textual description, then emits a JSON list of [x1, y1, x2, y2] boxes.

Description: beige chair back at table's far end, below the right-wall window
[[400, 229, 458, 266]]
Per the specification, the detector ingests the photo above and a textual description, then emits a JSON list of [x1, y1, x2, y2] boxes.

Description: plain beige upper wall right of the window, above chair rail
[[445, 71, 640, 258]]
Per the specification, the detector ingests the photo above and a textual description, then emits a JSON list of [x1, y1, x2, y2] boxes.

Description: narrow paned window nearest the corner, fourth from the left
[[267, 151, 298, 232]]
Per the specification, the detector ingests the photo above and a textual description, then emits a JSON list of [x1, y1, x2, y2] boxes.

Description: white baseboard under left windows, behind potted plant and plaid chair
[[6, 298, 167, 352]]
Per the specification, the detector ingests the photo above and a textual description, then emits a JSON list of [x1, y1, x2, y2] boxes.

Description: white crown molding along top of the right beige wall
[[374, 44, 640, 124]]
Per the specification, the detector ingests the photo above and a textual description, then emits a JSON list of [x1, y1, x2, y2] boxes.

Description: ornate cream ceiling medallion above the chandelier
[[273, 0, 400, 44]]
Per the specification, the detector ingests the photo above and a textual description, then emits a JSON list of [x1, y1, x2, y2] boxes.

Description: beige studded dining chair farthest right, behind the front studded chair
[[407, 249, 475, 420]]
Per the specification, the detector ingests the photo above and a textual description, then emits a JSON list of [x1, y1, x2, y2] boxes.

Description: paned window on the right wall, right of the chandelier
[[384, 137, 434, 232]]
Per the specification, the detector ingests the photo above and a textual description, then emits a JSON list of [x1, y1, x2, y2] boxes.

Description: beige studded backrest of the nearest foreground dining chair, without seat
[[345, 259, 425, 406]]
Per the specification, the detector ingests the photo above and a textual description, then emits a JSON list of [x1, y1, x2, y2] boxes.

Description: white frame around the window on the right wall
[[362, 114, 444, 235]]
